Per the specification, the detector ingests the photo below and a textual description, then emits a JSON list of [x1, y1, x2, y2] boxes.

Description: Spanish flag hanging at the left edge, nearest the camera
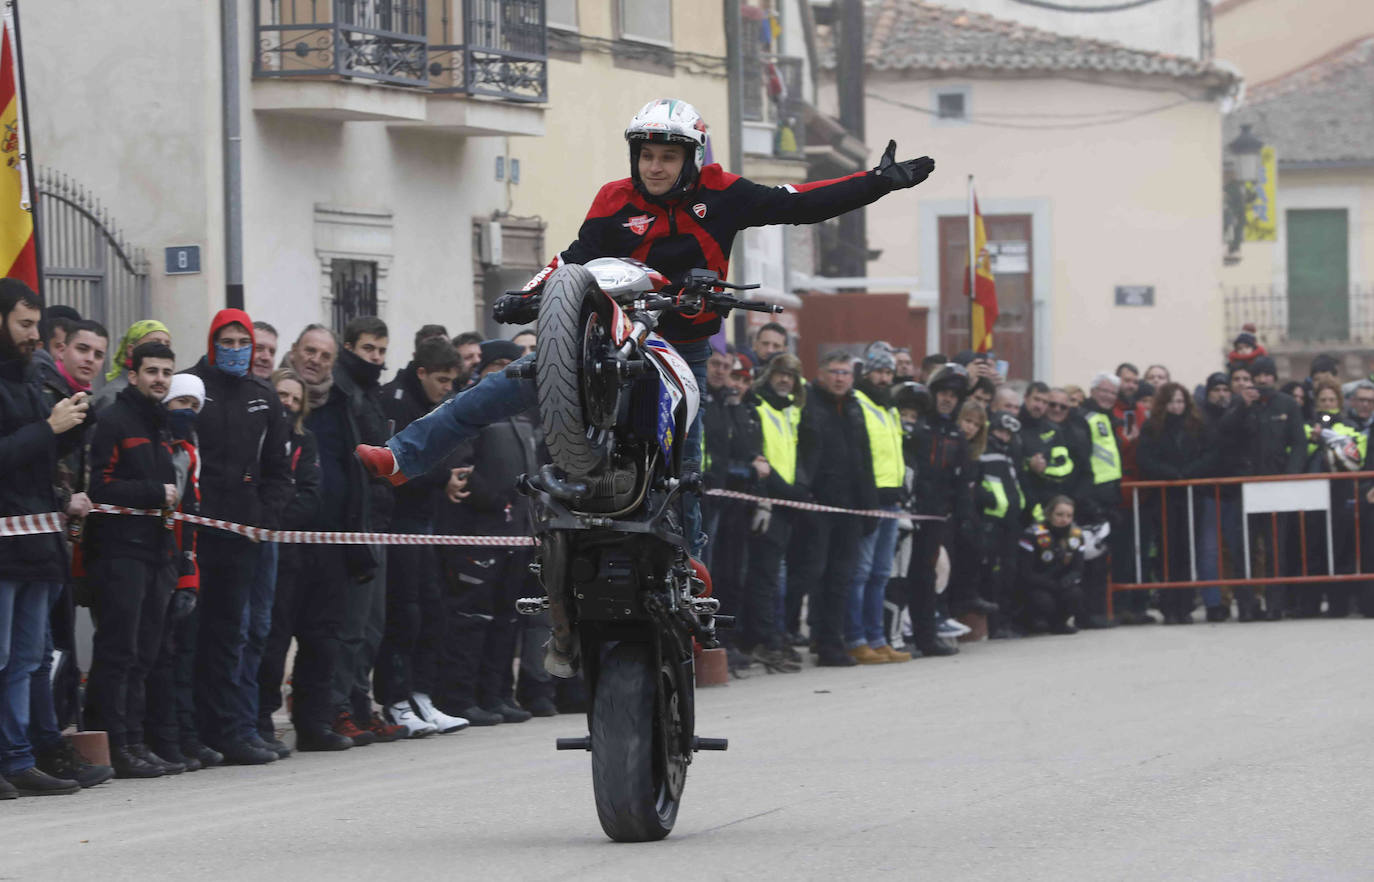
[[0, 4, 38, 291]]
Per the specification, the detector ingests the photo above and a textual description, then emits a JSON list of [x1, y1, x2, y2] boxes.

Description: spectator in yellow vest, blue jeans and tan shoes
[[845, 349, 911, 665]]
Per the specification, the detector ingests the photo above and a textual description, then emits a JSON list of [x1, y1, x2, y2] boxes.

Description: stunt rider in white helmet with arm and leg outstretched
[[357, 98, 934, 555]]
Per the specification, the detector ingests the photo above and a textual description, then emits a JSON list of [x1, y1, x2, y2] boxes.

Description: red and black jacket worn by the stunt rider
[[536, 163, 890, 343]]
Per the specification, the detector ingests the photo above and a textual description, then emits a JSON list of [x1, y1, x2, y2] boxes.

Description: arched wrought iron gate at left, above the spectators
[[37, 169, 150, 336]]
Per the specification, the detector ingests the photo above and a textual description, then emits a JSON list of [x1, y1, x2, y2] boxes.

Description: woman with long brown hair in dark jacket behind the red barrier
[[1132, 382, 1219, 625]]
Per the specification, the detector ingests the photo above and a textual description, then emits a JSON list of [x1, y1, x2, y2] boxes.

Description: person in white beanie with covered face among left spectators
[[143, 374, 212, 772]]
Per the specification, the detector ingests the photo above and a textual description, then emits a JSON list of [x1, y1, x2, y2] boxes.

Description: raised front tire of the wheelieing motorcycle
[[534, 264, 614, 478]]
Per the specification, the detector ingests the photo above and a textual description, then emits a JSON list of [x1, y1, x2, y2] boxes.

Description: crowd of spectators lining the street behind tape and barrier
[[0, 279, 1374, 798]]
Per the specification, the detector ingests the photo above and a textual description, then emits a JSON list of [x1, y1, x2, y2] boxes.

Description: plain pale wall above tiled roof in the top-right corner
[[1213, 0, 1374, 87]]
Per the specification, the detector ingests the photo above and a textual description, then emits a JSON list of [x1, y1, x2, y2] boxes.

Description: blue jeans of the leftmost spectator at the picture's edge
[[0, 581, 62, 775]]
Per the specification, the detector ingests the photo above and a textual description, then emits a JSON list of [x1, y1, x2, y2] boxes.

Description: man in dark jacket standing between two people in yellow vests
[[796, 352, 878, 668]]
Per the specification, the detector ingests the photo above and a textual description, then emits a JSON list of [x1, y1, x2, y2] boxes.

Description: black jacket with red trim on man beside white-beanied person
[[85, 386, 177, 563]]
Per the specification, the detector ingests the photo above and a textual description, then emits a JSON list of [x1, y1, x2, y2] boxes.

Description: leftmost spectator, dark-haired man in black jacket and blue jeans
[[0, 279, 88, 800]]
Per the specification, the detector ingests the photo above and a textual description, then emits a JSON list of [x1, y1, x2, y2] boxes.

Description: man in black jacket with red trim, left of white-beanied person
[[85, 343, 185, 778]]
